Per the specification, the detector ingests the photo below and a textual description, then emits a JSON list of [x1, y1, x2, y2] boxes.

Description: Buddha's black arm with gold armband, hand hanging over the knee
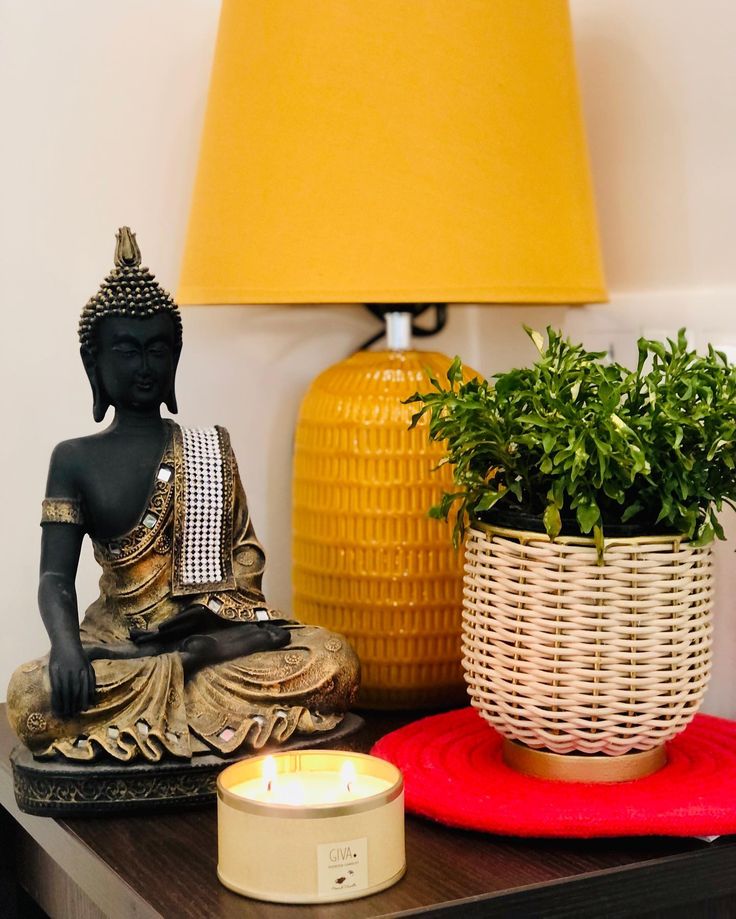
[[38, 445, 95, 717]]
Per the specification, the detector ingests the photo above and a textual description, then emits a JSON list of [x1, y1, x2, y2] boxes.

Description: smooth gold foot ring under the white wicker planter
[[503, 740, 667, 782]]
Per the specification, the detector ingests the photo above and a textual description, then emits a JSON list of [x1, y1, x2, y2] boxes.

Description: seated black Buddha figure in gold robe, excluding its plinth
[[8, 227, 358, 763]]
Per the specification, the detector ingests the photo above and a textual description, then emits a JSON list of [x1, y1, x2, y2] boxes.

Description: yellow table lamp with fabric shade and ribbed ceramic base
[[179, 0, 606, 708]]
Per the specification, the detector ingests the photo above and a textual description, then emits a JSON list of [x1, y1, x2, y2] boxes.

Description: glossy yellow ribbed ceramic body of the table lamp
[[293, 351, 465, 709]]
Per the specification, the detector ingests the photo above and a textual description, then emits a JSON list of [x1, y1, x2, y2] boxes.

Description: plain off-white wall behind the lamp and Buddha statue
[[0, 0, 736, 717]]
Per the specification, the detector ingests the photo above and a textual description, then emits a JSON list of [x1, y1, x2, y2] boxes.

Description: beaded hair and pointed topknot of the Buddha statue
[[79, 227, 181, 363]]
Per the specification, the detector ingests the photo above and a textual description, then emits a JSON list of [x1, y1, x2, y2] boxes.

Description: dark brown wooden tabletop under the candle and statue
[[0, 707, 736, 919]]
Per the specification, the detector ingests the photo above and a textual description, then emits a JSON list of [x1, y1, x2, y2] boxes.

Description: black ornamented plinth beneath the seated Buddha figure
[[10, 714, 365, 817]]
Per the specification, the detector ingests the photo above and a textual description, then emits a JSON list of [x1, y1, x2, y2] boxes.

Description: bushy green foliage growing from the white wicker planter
[[407, 327, 736, 552]]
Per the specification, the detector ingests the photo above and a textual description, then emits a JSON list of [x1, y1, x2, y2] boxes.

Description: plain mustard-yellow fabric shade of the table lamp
[[179, 0, 606, 304]]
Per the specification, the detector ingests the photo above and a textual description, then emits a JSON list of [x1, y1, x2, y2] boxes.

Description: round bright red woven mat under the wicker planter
[[372, 708, 736, 837]]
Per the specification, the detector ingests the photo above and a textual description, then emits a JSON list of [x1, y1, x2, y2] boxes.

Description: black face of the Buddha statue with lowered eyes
[[95, 313, 177, 412]]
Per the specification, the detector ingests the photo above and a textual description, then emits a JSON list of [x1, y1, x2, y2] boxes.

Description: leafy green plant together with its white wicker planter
[[409, 329, 736, 780]]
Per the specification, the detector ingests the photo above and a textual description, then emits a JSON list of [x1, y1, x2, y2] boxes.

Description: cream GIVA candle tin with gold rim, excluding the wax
[[217, 750, 406, 903]]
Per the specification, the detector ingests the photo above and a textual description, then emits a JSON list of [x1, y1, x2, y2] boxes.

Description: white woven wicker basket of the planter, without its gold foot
[[463, 524, 713, 756]]
